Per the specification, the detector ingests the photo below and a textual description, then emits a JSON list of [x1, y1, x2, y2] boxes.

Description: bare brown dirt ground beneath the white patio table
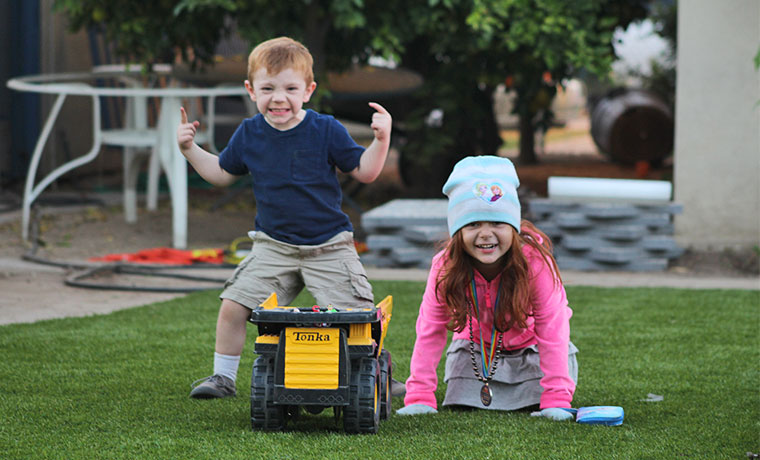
[[0, 190, 255, 261]]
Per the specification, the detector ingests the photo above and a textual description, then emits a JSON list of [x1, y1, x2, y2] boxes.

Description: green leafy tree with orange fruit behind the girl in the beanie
[[388, 0, 648, 192]]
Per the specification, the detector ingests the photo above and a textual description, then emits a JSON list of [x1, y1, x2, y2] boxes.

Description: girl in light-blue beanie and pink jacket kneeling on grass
[[397, 156, 578, 420]]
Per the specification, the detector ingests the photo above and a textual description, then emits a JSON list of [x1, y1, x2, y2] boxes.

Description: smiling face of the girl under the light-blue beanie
[[460, 221, 515, 280]]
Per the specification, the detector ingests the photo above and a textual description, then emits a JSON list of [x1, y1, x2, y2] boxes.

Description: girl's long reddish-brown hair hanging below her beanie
[[436, 220, 562, 332]]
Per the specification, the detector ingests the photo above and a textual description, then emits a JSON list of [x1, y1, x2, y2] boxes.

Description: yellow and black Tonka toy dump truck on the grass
[[250, 293, 393, 433]]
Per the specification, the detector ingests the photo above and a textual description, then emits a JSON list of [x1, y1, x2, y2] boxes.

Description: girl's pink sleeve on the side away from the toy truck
[[526, 251, 575, 409]]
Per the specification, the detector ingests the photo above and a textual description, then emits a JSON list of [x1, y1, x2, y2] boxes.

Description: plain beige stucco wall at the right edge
[[674, 0, 760, 249]]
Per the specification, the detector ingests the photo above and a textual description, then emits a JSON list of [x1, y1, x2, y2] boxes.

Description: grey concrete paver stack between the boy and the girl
[[361, 199, 449, 268]]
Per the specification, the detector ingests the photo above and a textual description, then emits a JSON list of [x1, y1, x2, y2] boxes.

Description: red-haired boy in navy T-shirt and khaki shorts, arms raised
[[177, 37, 391, 398]]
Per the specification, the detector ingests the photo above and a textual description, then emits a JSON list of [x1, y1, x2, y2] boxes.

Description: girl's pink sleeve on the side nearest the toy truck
[[404, 252, 449, 409]]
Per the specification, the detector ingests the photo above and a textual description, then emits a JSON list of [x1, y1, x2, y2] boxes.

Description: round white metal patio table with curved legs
[[7, 70, 245, 249]]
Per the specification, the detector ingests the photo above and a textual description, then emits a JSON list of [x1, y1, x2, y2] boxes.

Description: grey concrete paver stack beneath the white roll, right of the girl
[[526, 198, 683, 271]]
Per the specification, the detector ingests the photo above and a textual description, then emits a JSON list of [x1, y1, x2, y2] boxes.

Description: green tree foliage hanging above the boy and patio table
[[54, 0, 401, 107]]
